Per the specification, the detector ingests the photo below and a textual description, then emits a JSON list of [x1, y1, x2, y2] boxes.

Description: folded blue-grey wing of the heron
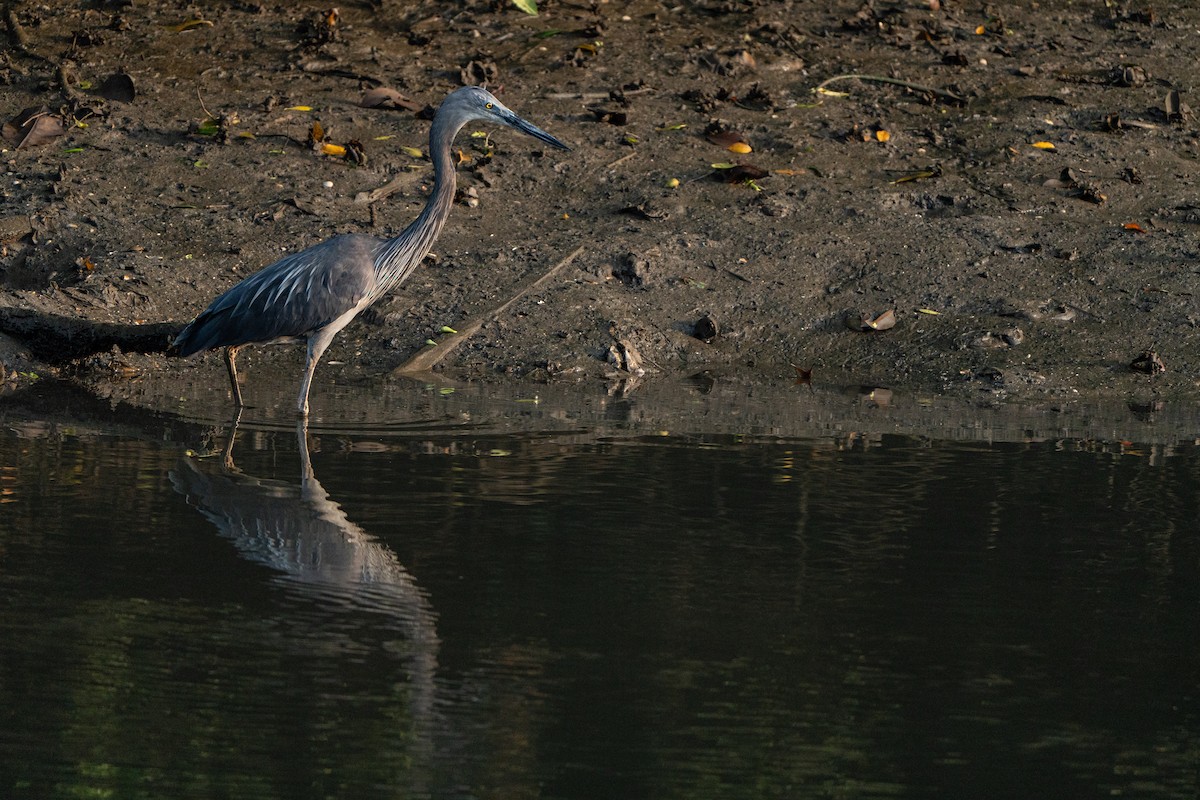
[[175, 235, 376, 355]]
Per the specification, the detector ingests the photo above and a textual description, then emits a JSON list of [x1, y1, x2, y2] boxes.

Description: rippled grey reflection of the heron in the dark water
[[170, 411, 439, 753]]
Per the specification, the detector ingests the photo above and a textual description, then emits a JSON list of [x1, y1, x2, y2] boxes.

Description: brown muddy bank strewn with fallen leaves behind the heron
[[0, 1, 1200, 412]]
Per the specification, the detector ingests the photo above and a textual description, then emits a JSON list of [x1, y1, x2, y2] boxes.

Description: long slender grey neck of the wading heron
[[376, 110, 462, 294]]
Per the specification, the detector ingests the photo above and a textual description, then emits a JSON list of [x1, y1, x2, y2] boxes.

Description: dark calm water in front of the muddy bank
[[0, 383, 1200, 799]]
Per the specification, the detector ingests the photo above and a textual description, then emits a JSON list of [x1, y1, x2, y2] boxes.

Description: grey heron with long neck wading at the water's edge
[[172, 86, 570, 417]]
